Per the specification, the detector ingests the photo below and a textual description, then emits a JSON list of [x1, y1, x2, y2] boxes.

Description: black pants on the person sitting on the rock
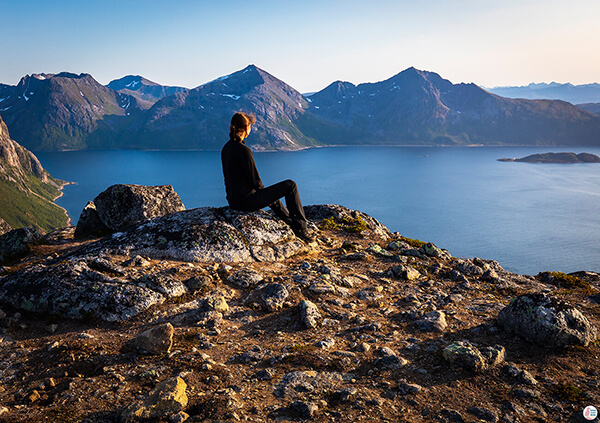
[[229, 179, 306, 229]]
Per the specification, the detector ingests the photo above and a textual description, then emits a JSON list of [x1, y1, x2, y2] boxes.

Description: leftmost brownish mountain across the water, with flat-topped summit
[[0, 72, 140, 151]]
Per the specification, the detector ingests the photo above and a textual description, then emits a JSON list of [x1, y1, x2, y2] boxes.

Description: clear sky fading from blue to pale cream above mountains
[[0, 0, 600, 92]]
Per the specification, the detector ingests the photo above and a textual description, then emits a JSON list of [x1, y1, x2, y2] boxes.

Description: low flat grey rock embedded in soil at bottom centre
[[274, 370, 342, 399]]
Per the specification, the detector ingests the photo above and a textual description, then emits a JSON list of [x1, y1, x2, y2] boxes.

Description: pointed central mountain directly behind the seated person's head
[[123, 65, 316, 150]]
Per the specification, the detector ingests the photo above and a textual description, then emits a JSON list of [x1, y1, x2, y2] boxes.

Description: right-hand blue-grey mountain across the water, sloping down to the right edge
[[308, 68, 600, 145]]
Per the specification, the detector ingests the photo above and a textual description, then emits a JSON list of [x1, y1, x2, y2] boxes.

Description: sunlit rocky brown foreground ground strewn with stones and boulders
[[0, 196, 600, 422]]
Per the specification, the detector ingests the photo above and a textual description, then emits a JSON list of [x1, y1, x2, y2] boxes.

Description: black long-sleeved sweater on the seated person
[[221, 140, 264, 206]]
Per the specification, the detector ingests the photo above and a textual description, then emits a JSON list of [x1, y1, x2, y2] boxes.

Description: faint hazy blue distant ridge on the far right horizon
[[488, 82, 600, 104]]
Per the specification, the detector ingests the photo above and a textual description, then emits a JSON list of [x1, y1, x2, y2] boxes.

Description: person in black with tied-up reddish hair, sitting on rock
[[221, 112, 314, 242]]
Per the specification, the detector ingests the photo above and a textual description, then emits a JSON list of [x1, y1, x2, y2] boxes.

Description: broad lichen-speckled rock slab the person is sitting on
[[89, 207, 306, 262]]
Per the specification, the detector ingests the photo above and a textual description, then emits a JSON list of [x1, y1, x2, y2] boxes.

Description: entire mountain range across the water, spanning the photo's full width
[[0, 65, 600, 151]]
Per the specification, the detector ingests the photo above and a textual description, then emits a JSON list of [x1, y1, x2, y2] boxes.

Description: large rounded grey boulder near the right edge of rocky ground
[[498, 293, 597, 347]]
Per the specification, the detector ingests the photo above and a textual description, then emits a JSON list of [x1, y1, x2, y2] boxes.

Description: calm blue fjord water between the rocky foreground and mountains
[[37, 147, 600, 274]]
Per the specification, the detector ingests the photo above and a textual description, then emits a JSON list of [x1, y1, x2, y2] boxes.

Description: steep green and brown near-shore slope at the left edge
[[0, 114, 67, 232]]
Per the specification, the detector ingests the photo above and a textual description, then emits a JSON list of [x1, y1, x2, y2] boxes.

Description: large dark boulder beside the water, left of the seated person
[[77, 184, 185, 236]]
